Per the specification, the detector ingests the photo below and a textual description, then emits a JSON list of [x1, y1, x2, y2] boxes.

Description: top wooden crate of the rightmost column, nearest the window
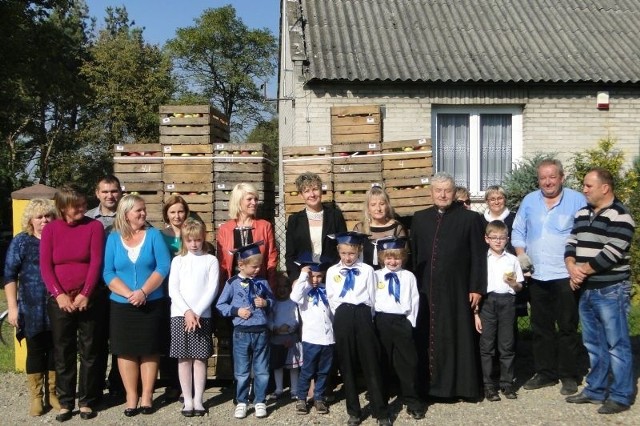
[[382, 139, 433, 179]]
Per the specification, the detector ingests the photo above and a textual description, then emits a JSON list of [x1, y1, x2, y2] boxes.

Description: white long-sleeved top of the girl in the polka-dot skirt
[[169, 252, 219, 318]]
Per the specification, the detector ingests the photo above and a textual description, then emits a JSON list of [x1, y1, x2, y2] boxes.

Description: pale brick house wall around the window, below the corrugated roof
[[280, 81, 640, 169]]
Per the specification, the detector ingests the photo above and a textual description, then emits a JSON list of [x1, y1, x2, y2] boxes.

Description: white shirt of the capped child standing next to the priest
[[375, 268, 420, 327]]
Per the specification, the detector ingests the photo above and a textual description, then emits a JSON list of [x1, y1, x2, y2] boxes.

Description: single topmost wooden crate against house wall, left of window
[[331, 105, 382, 145]]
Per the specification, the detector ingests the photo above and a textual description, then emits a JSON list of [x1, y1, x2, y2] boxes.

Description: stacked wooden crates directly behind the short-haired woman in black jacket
[[282, 145, 333, 220]]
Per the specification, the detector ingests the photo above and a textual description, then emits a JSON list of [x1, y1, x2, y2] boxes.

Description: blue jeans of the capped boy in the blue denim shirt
[[233, 330, 269, 404]]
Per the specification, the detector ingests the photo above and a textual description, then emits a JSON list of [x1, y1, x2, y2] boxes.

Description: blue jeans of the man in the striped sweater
[[580, 281, 633, 405]]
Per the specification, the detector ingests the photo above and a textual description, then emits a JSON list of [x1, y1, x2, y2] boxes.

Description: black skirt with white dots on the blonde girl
[[169, 317, 213, 359]]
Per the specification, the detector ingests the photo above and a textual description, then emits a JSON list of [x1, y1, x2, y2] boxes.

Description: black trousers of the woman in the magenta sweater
[[47, 297, 108, 410]]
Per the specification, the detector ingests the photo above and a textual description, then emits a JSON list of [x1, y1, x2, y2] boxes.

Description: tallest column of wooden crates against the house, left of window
[[331, 105, 383, 229]]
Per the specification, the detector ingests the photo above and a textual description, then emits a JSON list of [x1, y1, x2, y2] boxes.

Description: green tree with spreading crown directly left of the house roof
[[166, 5, 278, 136]]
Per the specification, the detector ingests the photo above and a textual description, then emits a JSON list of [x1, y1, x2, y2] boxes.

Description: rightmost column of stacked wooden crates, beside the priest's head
[[382, 139, 433, 216]]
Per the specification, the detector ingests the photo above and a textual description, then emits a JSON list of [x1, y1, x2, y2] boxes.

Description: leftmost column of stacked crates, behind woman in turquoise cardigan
[[113, 143, 163, 227]]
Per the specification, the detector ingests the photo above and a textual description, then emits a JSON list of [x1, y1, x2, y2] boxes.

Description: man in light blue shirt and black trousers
[[511, 159, 587, 395]]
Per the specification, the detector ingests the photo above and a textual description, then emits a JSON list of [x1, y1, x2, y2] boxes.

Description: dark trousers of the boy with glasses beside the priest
[[480, 293, 516, 387]]
